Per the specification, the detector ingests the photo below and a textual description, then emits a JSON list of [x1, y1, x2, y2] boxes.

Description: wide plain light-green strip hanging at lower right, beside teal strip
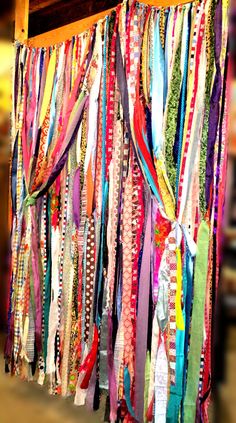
[[184, 221, 210, 423]]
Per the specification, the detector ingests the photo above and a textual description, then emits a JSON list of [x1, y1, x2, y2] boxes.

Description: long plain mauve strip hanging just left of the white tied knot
[[135, 197, 151, 422]]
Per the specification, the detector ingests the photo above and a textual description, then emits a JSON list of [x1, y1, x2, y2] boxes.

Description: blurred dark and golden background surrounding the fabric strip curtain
[[0, 0, 236, 423]]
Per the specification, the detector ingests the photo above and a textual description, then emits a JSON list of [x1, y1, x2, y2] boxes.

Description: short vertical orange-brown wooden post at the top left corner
[[15, 0, 29, 43]]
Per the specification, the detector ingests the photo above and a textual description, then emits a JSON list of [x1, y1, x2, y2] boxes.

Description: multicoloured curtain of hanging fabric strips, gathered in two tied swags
[[5, 0, 228, 423]]
